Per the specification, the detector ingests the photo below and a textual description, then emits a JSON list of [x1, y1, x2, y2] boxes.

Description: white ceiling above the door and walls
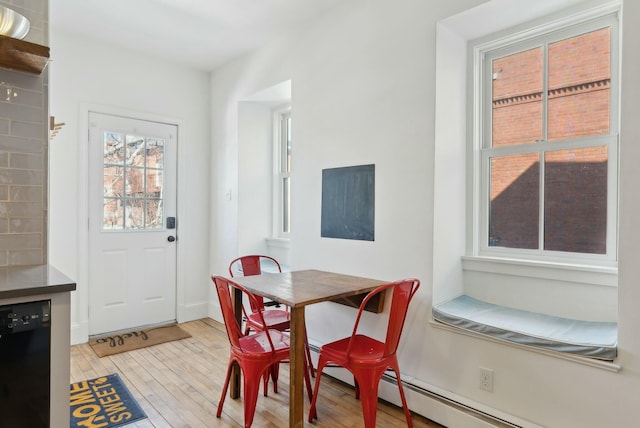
[[49, 0, 347, 71]]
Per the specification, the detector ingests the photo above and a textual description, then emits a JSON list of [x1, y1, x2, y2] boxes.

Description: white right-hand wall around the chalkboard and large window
[[210, 0, 640, 428]]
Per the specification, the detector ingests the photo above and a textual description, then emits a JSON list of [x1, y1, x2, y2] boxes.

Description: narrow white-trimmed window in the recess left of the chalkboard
[[273, 107, 291, 238]]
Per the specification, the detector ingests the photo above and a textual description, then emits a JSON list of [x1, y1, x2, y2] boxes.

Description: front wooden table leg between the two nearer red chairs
[[289, 306, 305, 428]]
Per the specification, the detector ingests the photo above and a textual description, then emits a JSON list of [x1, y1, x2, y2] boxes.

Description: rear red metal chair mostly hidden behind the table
[[229, 254, 315, 396]]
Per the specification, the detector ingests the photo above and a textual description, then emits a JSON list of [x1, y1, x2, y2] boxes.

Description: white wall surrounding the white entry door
[[49, 29, 210, 343]]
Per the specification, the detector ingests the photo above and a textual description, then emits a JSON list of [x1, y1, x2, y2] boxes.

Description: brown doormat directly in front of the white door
[[89, 324, 191, 358]]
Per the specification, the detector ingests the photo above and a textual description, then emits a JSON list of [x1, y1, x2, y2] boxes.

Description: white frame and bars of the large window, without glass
[[471, 10, 619, 266]]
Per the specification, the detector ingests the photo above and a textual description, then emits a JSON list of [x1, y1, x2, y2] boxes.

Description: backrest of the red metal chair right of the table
[[349, 279, 420, 357]]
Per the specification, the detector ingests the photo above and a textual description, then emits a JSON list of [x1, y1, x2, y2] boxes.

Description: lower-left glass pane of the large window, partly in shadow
[[488, 153, 540, 249]]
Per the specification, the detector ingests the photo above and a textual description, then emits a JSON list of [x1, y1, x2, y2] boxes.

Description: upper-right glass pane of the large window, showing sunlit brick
[[547, 28, 611, 141]]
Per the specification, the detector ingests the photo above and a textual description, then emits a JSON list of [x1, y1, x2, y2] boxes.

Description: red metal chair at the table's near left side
[[211, 276, 311, 428]]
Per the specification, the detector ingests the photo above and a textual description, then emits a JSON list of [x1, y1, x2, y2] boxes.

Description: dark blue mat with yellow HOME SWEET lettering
[[69, 373, 147, 428]]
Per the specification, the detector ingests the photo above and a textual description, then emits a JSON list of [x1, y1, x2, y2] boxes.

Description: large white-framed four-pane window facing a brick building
[[471, 13, 619, 266]]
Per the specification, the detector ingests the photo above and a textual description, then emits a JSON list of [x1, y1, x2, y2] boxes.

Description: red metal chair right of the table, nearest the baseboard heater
[[309, 279, 420, 428]]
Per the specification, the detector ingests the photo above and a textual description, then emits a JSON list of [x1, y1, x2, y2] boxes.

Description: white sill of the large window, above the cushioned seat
[[462, 256, 618, 287]]
